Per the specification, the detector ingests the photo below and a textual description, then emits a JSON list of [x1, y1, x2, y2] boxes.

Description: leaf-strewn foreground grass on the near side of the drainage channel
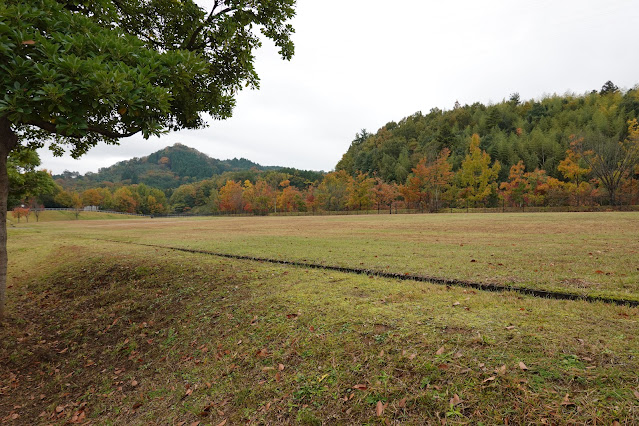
[[0, 220, 639, 425]]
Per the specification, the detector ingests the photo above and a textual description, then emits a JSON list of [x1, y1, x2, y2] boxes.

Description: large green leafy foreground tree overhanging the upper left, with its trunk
[[0, 0, 295, 318]]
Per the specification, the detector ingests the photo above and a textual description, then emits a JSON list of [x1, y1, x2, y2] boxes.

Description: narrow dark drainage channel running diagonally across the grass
[[100, 240, 639, 307]]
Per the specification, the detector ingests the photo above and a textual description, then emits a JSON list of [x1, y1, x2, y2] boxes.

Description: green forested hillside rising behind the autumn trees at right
[[336, 82, 639, 183]]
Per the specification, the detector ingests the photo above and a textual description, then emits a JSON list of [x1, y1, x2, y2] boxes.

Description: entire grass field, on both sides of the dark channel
[[0, 213, 639, 425]]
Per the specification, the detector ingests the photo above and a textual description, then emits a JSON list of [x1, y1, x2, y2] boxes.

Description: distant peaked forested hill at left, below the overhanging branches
[[54, 143, 279, 191]]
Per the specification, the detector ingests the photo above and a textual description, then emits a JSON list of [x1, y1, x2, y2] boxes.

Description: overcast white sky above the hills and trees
[[40, 0, 639, 173]]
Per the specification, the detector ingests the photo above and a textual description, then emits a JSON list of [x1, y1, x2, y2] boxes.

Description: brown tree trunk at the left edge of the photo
[[0, 117, 18, 322]]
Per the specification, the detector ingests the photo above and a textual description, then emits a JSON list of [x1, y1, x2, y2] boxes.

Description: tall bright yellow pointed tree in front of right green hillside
[[458, 134, 501, 205]]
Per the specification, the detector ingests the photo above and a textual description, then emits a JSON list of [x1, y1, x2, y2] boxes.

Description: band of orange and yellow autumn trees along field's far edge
[[35, 119, 639, 215]]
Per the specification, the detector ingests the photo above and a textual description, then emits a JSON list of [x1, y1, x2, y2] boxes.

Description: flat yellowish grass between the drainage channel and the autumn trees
[[20, 212, 639, 300]]
